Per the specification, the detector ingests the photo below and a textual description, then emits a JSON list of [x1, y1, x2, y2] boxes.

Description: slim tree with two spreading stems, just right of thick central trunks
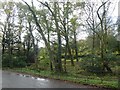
[[61, 2, 74, 66]]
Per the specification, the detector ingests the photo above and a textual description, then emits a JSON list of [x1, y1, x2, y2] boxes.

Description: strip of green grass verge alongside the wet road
[[2, 68, 118, 89]]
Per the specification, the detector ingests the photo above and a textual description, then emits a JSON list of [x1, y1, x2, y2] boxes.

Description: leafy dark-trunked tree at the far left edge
[[2, 2, 15, 66]]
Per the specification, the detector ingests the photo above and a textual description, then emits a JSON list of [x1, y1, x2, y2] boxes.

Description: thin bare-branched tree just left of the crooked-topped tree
[[84, 2, 99, 65]]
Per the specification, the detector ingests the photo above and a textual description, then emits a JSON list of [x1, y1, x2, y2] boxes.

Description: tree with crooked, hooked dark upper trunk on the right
[[97, 2, 112, 72]]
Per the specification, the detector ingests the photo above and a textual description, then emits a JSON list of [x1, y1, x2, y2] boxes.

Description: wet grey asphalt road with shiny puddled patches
[[2, 71, 108, 88]]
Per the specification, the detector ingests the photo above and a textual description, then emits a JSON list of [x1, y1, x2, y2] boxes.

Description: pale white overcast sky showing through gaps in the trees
[[0, 0, 120, 47]]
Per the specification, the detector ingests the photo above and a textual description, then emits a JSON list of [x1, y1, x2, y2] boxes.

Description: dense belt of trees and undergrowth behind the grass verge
[[0, 0, 120, 88]]
